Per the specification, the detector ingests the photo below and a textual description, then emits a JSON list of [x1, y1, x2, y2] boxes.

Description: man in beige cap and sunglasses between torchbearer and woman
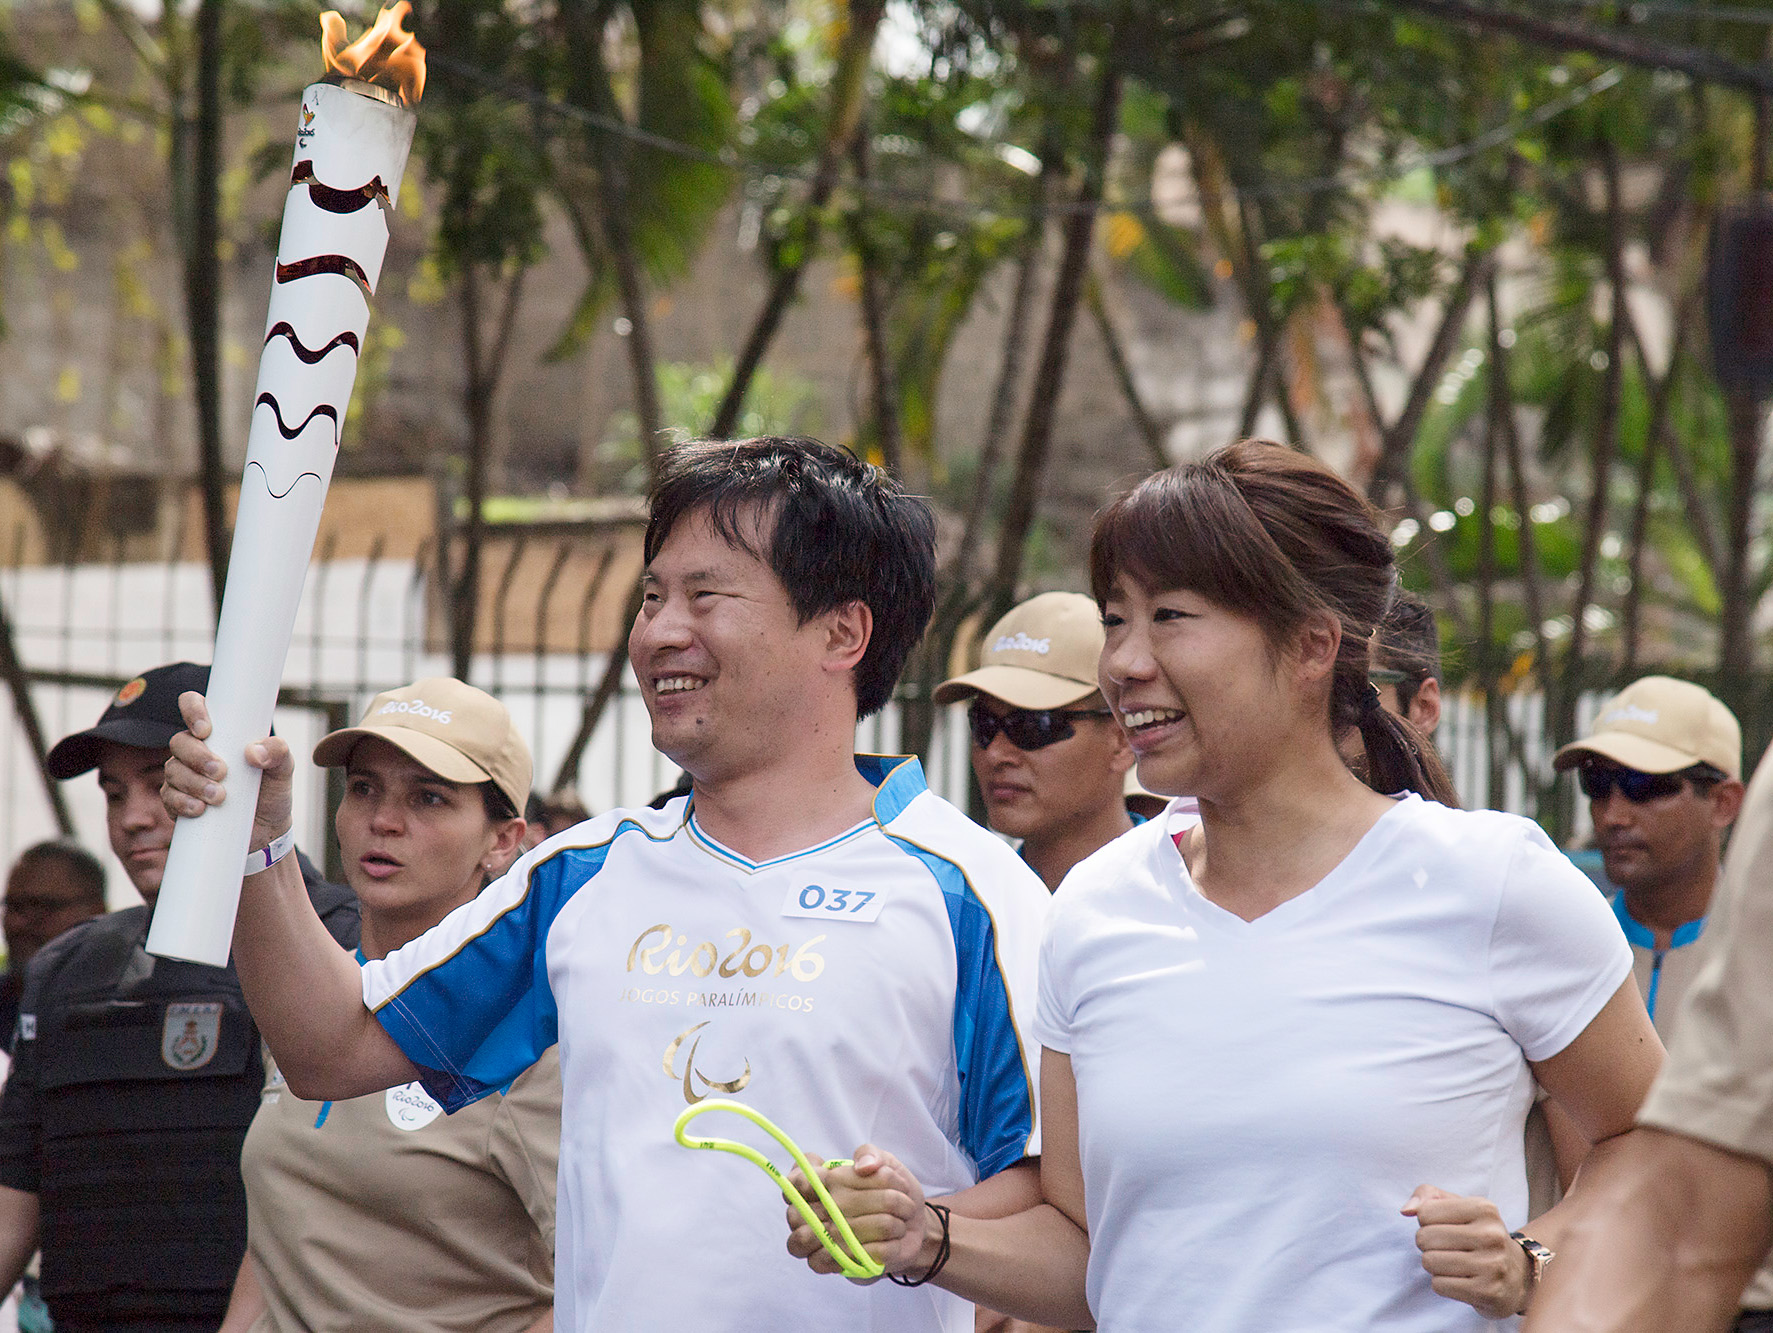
[[936, 592, 1133, 888]]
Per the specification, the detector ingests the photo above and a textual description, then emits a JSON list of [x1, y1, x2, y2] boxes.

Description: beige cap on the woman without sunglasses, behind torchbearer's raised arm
[[314, 675, 532, 814]]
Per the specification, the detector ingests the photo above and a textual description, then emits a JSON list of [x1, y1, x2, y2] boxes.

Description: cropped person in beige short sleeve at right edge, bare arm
[[1527, 698, 1773, 1333]]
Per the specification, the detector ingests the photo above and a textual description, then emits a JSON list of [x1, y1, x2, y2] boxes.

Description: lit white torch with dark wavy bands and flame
[[147, 0, 426, 966]]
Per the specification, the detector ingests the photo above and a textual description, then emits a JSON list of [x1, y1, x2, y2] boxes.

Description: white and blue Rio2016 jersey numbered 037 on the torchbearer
[[363, 757, 1050, 1333]]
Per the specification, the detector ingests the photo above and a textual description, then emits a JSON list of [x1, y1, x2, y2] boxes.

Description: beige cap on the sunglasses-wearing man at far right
[[1551, 675, 1743, 778]]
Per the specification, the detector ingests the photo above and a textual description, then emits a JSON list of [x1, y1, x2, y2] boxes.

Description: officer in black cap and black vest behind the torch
[[0, 663, 356, 1333]]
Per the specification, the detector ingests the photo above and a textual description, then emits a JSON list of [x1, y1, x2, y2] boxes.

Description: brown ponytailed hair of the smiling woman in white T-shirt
[[1090, 440, 1459, 805]]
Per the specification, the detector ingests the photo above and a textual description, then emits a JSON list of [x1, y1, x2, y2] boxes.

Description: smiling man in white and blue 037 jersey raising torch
[[167, 438, 1046, 1333]]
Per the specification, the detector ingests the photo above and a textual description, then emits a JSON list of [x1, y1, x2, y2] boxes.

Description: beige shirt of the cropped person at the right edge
[[1638, 764, 1773, 1310]]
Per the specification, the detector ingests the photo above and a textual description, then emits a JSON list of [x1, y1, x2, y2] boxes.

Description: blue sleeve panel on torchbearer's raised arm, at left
[[376, 819, 665, 1111]]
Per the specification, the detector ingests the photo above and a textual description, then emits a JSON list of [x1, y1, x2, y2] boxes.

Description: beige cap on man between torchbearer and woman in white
[[936, 592, 1103, 709]]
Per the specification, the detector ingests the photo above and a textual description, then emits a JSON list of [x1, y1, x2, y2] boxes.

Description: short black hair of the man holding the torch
[[645, 434, 936, 718]]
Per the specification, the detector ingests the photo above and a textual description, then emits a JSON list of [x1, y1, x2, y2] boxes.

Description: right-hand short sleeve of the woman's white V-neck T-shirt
[[1489, 819, 1631, 1060]]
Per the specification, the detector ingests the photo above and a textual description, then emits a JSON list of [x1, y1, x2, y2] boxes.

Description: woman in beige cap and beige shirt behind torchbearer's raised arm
[[223, 679, 560, 1333]]
